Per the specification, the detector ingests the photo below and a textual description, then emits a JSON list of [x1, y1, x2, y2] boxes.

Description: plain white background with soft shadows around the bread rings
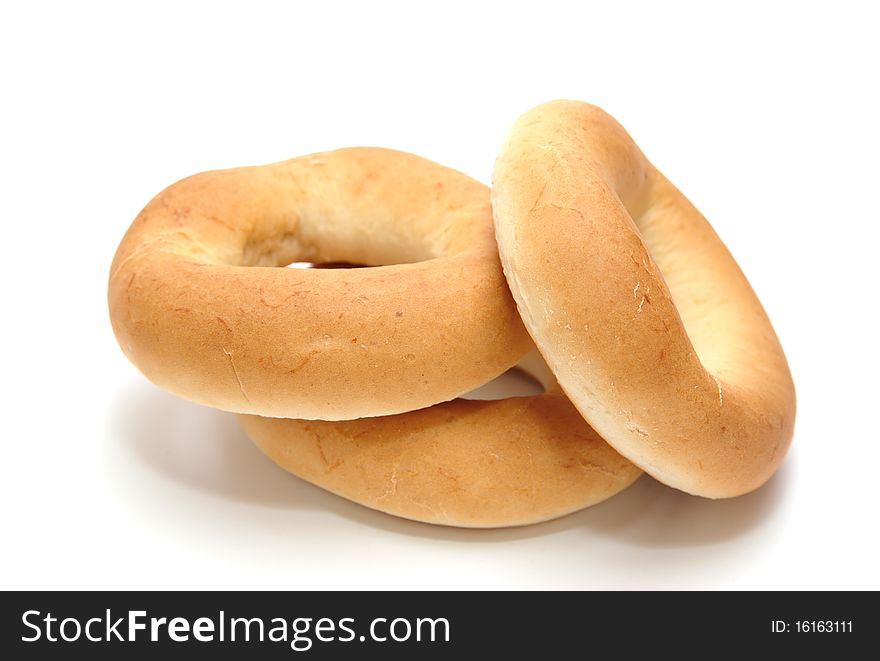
[[0, 0, 880, 589]]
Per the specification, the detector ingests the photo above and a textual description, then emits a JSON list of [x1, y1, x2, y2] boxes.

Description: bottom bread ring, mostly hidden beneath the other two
[[239, 350, 641, 528]]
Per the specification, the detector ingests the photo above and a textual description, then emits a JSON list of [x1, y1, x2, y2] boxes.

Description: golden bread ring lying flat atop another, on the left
[[108, 148, 532, 420]]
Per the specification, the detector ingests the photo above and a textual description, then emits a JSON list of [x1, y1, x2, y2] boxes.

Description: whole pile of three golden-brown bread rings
[[109, 101, 795, 527]]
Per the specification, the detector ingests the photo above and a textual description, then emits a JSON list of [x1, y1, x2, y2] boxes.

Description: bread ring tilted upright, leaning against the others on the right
[[492, 101, 795, 498]]
